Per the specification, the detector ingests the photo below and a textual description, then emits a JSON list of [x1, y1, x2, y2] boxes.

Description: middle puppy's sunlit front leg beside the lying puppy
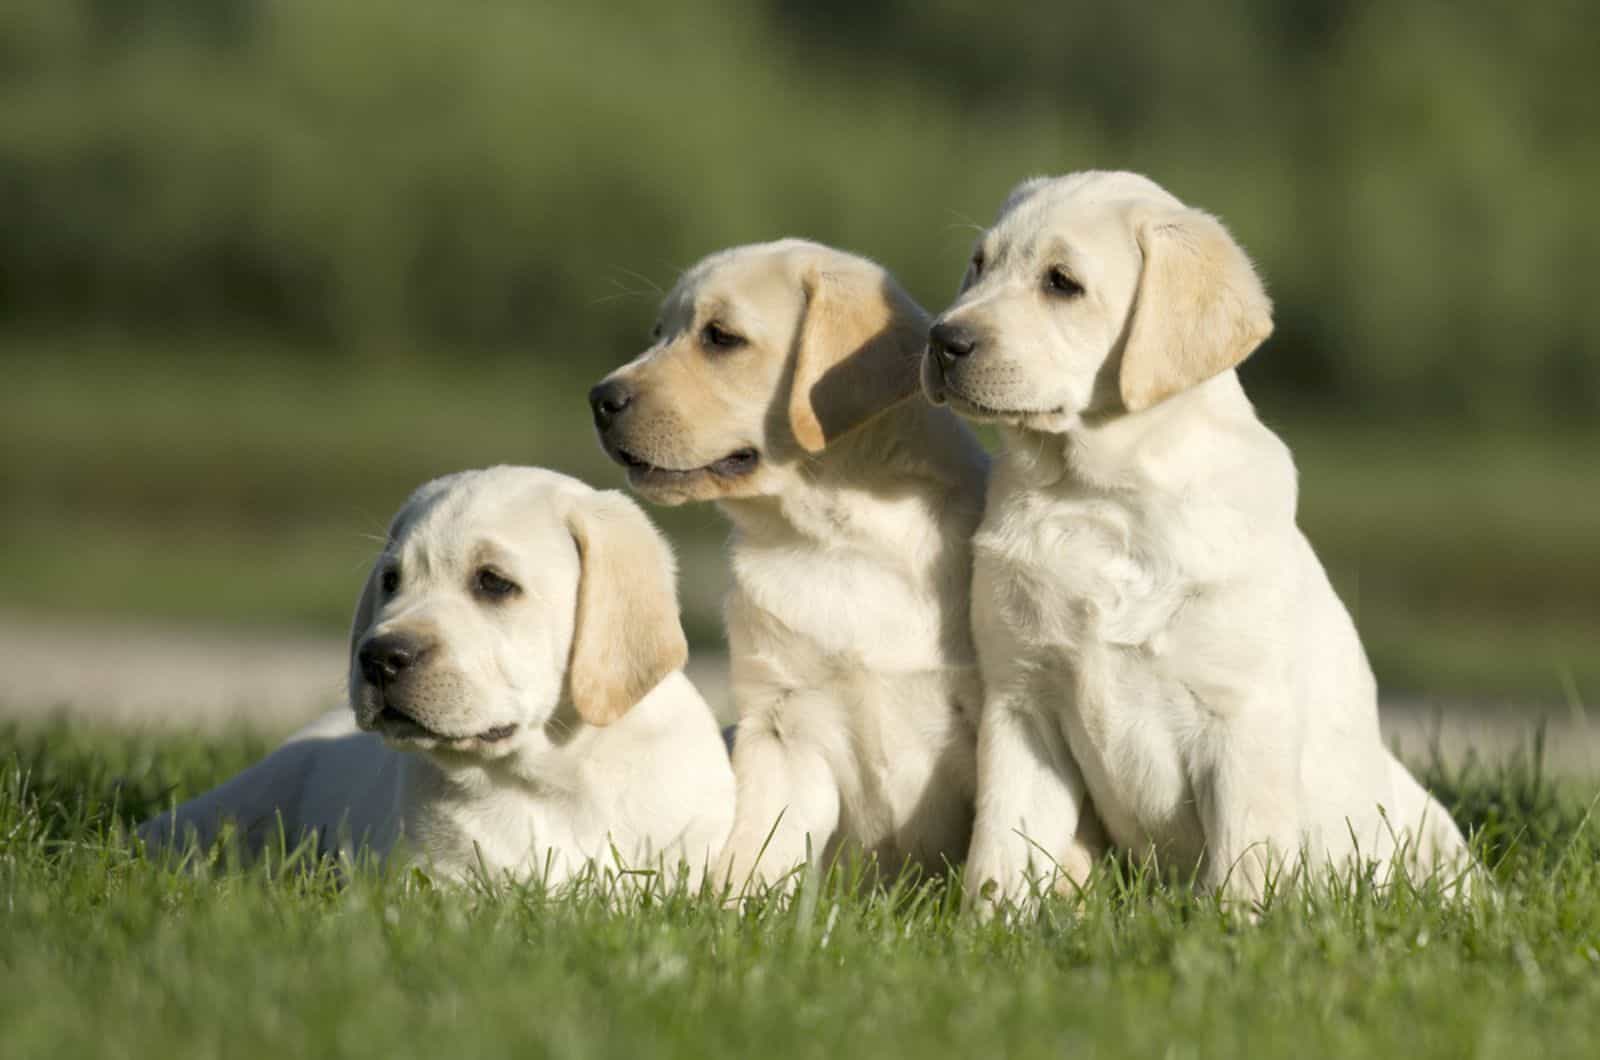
[[714, 719, 838, 893]]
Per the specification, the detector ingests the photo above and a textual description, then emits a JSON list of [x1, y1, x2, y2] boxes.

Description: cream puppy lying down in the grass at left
[[139, 468, 733, 884]]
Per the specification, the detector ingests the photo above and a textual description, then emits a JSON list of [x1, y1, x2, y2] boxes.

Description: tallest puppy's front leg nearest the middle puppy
[[965, 697, 1104, 916]]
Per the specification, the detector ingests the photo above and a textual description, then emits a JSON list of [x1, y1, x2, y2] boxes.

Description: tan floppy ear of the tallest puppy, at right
[[1118, 210, 1272, 412]]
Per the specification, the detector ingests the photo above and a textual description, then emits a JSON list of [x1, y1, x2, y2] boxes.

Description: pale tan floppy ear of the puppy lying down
[[566, 490, 690, 725]]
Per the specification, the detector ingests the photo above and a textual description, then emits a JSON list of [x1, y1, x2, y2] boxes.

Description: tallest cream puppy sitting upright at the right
[[923, 173, 1470, 901]]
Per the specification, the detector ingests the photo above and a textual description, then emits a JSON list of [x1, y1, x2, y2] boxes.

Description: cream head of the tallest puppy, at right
[[922, 173, 1272, 432]]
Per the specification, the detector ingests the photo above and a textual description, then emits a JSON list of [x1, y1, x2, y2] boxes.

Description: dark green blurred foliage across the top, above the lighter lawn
[[0, 0, 1600, 423]]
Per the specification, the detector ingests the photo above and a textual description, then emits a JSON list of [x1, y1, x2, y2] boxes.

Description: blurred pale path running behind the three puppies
[[0, 613, 1600, 777]]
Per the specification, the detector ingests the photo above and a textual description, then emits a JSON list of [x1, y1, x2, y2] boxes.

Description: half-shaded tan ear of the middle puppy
[[789, 269, 928, 453]]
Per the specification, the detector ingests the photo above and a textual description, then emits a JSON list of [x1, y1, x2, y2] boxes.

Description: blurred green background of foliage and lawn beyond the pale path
[[0, 0, 1600, 703]]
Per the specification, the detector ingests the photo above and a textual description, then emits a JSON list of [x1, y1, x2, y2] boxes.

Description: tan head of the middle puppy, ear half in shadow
[[589, 240, 926, 504]]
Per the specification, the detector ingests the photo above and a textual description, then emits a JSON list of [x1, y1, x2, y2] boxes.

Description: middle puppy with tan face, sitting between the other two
[[590, 240, 1030, 887]]
